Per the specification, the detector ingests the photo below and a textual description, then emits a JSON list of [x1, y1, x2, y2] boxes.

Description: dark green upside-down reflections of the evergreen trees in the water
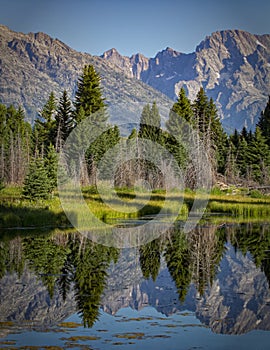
[[0, 224, 270, 327]]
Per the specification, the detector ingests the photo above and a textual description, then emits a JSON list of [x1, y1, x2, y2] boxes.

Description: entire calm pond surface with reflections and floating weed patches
[[0, 223, 270, 349]]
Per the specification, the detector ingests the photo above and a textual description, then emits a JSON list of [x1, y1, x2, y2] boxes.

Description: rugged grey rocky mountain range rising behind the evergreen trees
[[0, 25, 270, 131]]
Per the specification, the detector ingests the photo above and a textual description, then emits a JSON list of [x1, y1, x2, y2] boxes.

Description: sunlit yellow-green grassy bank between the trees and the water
[[0, 187, 270, 228]]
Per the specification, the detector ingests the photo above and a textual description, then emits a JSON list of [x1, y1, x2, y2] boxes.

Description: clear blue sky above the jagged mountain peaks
[[0, 0, 270, 57]]
